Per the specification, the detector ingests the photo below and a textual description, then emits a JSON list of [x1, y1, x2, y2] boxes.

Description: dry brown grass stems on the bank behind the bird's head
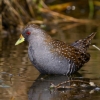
[[0, 0, 96, 30]]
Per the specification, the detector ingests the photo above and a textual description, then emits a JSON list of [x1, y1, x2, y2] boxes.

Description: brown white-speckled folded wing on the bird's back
[[51, 40, 90, 66]]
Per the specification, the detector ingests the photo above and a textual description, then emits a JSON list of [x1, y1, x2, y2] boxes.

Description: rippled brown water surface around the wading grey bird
[[0, 25, 100, 100]]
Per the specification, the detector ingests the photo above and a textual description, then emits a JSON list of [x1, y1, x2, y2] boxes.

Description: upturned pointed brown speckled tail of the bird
[[72, 32, 96, 53]]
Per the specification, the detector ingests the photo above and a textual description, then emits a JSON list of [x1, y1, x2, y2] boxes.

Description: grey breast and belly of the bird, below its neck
[[28, 43, 78, 74]]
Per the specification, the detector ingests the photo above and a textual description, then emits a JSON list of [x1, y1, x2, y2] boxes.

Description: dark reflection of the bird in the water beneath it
[[28, 75, 100, 100]]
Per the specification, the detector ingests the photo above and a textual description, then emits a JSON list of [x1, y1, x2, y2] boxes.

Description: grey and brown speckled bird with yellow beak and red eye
[[15, 24, 96, 75]]
